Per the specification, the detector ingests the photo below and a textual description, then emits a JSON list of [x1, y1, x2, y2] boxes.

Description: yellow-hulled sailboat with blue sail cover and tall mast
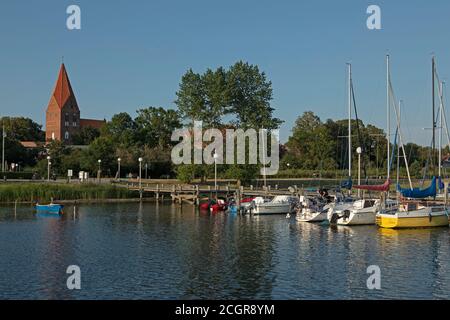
[[377, 57, 449, 228]]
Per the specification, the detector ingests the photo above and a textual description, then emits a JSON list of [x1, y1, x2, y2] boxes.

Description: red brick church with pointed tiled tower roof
[[45, 63, 106, 145]]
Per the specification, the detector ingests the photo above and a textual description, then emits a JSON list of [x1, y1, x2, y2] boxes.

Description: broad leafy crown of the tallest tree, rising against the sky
[[175, 61, 282, 129]]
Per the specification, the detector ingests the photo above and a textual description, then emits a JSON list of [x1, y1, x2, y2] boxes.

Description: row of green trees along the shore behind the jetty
[[0, 61, 442, 181]]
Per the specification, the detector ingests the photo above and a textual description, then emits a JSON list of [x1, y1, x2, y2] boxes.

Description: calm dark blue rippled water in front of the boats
[[0, 203, 450, 299]]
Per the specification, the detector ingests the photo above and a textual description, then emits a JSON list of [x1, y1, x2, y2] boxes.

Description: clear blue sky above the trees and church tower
[[0, 0, 450, 145]]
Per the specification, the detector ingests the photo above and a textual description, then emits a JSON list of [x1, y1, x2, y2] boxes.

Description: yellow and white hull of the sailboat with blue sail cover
[[376, 211, 449, 229]]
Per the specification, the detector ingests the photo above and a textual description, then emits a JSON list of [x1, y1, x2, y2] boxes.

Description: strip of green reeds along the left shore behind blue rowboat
[[0, 183, 139, 203]]
